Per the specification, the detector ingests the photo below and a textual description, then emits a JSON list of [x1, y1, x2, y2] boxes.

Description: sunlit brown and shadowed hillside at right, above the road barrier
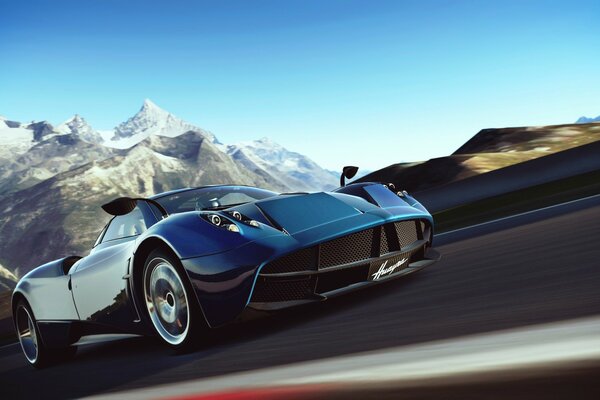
[[358, 123, 600, 192]]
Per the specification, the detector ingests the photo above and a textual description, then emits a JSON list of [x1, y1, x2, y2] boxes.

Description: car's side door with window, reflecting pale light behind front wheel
[[71, 201, 156, 332]]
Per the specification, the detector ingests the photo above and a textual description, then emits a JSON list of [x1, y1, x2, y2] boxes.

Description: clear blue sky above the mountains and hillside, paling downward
[[0, 0, 600, 169]]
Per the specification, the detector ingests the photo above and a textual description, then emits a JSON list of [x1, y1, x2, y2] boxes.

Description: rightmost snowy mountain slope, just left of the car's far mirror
[[226, 138, 337, 191]]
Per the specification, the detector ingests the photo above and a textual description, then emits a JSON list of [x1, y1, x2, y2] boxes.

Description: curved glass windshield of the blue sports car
[[155, 186, 277, 214]]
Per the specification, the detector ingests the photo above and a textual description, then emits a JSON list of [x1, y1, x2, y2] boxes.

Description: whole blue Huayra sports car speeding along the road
[[12, 167, 439, 367]]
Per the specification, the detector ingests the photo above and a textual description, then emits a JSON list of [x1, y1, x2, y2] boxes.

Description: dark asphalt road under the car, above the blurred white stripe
[[0, 197, 600, 399]]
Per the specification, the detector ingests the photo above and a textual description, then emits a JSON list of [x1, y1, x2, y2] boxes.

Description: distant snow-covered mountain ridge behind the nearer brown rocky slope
[[0, 100, 337, 193]]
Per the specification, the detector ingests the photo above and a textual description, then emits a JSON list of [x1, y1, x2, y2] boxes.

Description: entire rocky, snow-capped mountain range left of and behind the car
[[0, 100, 337, 287]]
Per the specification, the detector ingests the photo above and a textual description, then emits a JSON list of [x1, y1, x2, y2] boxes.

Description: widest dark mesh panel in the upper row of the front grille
[[319, 229, 373, 268]]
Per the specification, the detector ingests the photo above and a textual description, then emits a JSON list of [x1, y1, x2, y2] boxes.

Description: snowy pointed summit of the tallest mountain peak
[[105, 99, 218, 149]]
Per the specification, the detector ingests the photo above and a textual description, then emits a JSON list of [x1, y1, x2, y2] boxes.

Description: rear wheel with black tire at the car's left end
[[14, 299, 77, 368]]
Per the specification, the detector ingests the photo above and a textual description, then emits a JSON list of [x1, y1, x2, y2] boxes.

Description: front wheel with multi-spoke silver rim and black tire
[[141, 249, 207, 352]]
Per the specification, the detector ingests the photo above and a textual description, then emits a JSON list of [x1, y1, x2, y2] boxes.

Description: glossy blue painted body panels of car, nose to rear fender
[[13, 183, 433, 337]]
